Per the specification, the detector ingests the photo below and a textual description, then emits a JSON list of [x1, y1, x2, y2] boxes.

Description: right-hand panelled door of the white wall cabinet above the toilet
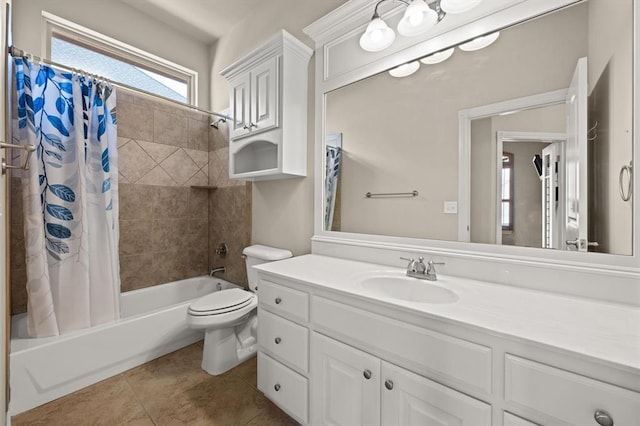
[[249, 57, 279, 132]]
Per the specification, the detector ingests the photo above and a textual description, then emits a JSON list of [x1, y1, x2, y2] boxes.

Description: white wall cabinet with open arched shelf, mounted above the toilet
[[221, 30, 312, 180]]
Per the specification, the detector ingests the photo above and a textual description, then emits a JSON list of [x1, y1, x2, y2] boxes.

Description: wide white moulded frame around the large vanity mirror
[[304, 0, 640, 300]]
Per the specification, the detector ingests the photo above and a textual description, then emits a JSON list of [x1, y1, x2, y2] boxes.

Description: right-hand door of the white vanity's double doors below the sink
[[381, 361, 491, 426]]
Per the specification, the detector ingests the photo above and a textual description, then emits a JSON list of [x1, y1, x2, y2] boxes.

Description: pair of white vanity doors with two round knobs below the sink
[[311, 333, 491, 426]]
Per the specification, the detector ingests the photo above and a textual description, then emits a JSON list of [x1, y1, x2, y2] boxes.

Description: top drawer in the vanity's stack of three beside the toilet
[[258, 279, 309, 322]]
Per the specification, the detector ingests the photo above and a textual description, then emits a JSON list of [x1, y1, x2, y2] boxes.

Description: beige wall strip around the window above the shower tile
[[13, 0, 211, 108]]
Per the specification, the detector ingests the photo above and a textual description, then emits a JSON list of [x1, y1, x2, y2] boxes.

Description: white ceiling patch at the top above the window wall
[[121, 0, 266, 44]]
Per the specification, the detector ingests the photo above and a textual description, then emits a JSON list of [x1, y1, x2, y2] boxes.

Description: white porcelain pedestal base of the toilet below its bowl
[[202, 314, 258, 376]]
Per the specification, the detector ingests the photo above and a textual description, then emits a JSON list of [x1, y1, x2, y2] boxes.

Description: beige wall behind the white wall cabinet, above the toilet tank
[[211, 0, 344, 255]]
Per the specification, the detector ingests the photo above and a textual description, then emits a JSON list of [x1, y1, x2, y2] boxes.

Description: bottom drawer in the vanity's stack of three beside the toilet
[[258, 352, 308, 424]]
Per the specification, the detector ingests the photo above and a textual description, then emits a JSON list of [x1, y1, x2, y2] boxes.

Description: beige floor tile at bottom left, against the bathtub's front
[[11, 376, 153, 426]]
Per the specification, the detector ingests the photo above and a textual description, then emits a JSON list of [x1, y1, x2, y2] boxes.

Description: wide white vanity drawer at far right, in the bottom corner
[[505, 355, 640, 425]]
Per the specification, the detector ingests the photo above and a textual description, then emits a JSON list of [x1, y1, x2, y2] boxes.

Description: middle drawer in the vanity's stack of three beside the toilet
[[258, 309, 309, 373]]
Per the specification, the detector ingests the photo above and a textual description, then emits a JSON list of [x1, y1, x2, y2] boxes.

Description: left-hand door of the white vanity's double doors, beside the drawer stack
[[311, 333, 380, 426]]
